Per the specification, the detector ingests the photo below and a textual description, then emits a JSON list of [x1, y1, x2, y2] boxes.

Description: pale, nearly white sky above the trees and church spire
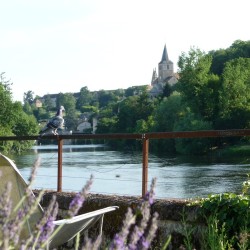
[[0, 0, 250, 101]]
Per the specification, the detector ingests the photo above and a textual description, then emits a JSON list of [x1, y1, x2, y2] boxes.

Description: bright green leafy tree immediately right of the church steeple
[[177, 46, 221, 124]]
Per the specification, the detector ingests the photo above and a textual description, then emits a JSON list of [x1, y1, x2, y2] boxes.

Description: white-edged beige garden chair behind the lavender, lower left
[[0, 153, 118, 248]]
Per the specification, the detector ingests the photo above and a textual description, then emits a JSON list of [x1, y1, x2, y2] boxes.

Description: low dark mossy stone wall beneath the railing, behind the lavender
[[37, 191, 201, 249]]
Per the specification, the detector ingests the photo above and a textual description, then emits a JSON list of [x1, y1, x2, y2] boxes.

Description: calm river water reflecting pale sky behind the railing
[[7, 145, 250, 198]]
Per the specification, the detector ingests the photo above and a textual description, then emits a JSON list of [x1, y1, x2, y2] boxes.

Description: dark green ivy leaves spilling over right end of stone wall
[[195, 185, 250, 249]]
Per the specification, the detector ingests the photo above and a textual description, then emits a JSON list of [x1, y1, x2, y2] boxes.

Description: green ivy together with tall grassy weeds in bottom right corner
[[185, 176, 250, 250]]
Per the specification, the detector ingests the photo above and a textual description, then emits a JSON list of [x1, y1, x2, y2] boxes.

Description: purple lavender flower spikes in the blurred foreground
[[0, 159, 158, 250]]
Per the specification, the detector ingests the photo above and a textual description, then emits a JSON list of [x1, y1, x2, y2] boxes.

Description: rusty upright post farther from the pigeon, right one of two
[[142, 134, 149, 197]]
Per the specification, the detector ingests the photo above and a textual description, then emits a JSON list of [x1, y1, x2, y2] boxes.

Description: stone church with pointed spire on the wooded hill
[[149, 45, 178, 97]]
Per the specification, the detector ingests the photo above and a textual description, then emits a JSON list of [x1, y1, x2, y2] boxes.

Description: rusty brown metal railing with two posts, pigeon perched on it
[[0, 129, 250, 196]]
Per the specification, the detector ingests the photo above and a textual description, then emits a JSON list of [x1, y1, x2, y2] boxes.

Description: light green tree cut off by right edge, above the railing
[[220, 58, 250, 128]]
